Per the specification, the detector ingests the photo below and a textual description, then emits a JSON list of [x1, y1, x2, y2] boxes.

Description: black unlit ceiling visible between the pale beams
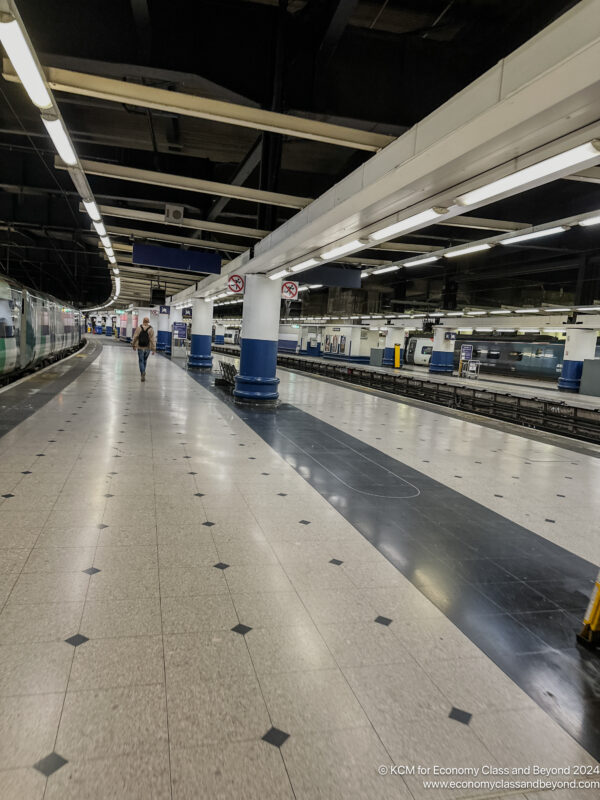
[[0, 0, 600, 310]]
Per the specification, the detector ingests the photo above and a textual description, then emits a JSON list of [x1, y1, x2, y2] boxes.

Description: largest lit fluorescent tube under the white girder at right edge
[[457, 139, 600, 206]]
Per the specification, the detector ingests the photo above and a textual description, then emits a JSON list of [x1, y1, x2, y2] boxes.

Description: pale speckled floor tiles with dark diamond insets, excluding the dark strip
[[0, 344, 600, 800]]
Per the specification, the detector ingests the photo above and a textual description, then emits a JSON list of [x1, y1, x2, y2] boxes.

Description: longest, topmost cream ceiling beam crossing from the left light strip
[[2, 58, 394, 153]]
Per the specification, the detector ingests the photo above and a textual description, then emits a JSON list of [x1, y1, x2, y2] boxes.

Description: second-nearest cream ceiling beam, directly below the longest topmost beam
[[54, 156, 312, 209]]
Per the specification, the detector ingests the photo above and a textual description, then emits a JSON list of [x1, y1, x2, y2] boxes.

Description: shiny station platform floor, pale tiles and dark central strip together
[[0, 339, 600, 800]]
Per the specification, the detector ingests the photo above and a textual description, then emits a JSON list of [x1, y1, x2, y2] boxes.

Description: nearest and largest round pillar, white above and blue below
[[233, 275, 281, 402]]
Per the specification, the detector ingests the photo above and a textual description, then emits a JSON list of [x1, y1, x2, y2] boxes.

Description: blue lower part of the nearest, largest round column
[[233, 339, 279, 403]]
